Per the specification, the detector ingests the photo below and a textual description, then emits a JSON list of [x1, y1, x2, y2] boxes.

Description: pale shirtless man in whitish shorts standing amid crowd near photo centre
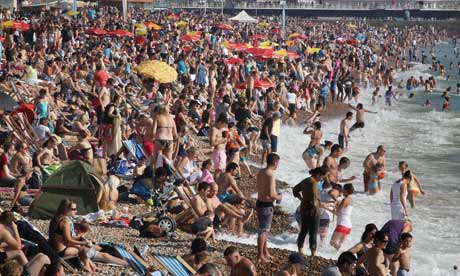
[[209, 116, 228, 175]]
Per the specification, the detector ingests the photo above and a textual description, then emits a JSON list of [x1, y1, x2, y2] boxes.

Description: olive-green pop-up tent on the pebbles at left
[[29, 161, 103, 219]]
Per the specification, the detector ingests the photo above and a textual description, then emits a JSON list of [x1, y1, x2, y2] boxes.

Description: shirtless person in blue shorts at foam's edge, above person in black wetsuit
[[302, 122, 324, 169]]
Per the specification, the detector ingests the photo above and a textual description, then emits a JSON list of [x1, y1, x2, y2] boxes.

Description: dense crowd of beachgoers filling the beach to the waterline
[[0, 3, 447, 275]]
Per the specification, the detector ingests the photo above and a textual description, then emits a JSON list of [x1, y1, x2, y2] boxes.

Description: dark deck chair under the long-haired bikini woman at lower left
[[14, 213, 78, 274]]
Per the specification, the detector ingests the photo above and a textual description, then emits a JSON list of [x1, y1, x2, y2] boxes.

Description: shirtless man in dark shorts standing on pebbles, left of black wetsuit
[[256, 153, 283, 263]]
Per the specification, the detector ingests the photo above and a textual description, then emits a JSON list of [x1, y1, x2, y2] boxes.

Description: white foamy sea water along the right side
[[219, 44, 460, 276]]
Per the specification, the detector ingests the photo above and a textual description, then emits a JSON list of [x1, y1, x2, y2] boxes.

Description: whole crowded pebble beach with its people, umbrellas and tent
[[0, 7, 454, 276]]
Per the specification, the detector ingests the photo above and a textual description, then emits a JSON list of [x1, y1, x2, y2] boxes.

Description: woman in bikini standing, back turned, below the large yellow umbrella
[[153, 105, 177, 162]]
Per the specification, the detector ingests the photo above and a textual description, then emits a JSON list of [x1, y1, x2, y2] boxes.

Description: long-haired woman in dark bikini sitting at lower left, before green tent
[[49, 199, 96, 273]]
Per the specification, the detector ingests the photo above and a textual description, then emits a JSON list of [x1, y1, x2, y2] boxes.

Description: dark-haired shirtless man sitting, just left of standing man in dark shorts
[[216, 162, 248, 204]]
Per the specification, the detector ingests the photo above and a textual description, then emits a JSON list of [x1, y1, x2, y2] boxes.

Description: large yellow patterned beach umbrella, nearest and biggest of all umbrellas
[[136, 60, 177, 83]]
